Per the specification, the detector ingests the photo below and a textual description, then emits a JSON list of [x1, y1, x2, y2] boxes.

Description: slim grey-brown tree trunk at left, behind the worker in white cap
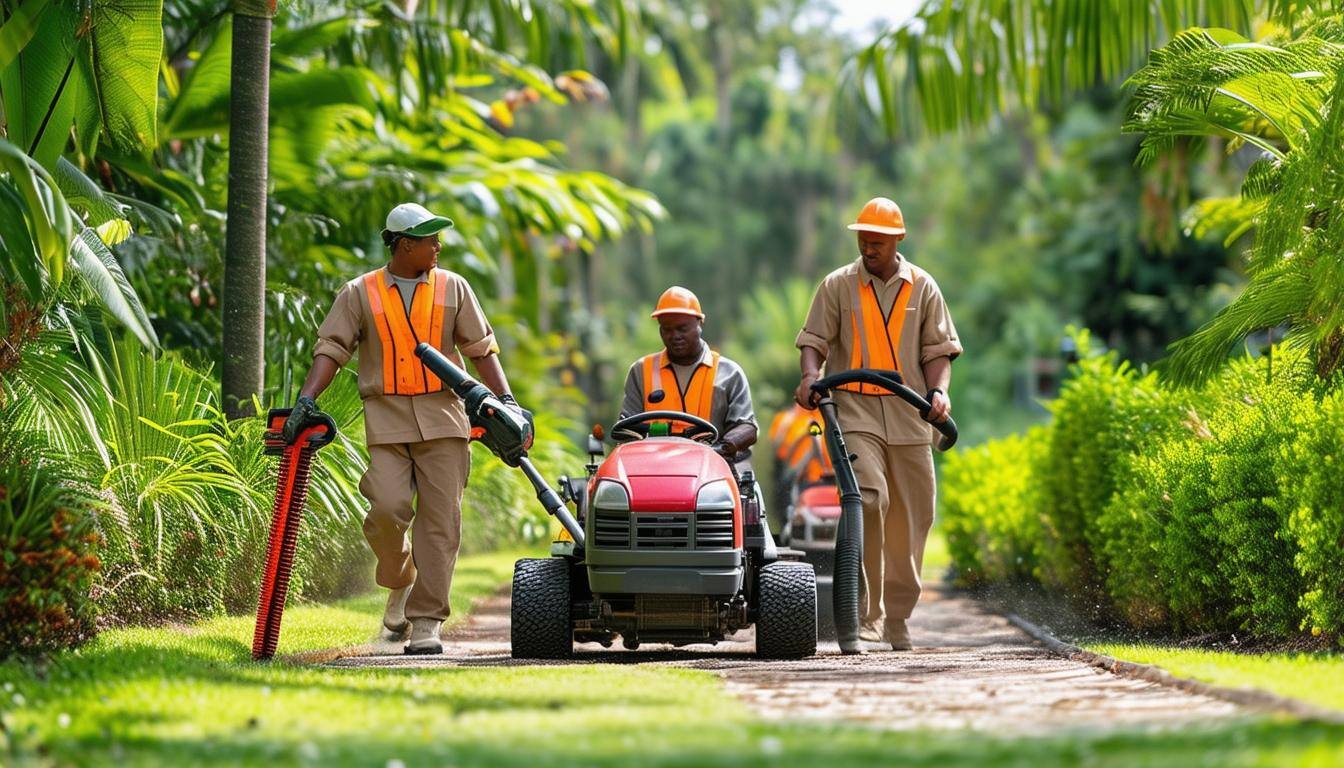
[[222, 0, 273, 418]]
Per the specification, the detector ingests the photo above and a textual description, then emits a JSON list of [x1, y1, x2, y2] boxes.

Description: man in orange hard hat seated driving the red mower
[[621, 285, 757, 459]]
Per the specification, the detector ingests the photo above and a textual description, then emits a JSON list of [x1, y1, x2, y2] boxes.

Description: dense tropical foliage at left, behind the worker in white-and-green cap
[[0, 0, 663, 642]]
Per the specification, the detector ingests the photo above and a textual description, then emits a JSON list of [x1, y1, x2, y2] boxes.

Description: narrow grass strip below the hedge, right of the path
[[1085, 643, 1344, 710]]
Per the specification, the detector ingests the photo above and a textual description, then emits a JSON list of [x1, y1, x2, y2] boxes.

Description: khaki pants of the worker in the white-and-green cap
[[359, 437, 472, 620]]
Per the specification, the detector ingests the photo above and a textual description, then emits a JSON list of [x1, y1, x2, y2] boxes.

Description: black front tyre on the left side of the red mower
[[508, 557, 574, 659]]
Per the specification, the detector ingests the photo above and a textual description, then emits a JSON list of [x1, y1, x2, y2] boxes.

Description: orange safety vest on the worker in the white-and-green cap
[[364, 269, 448, 394]]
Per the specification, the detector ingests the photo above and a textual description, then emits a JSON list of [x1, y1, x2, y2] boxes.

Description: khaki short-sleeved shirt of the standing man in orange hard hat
[[794, 254, 961, 445]]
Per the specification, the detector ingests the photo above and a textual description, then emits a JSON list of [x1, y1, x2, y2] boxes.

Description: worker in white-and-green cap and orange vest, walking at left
[[285, 203, 521, 654]]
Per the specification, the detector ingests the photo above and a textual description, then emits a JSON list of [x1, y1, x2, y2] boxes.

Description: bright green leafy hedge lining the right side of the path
[[942, 350, 1344, 638]]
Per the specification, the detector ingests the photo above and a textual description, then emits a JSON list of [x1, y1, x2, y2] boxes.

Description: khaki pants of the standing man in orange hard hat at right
[[844, 432, 935, 627]]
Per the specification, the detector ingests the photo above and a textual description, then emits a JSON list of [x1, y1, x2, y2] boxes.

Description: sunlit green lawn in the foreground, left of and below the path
[[0, 555, 1344, 768]]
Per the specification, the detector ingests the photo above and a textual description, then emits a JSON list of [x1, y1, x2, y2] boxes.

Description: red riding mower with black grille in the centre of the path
[[417, 344, 817, 659]]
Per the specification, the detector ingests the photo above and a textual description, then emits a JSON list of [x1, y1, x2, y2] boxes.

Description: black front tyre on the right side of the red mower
[[757, 562, 817, 659]]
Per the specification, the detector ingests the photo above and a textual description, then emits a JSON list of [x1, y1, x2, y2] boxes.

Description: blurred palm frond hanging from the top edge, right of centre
[[849, 0, 1257, 135]]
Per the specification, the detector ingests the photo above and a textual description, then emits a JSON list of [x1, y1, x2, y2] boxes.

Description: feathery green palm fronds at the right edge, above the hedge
[[1125, 17, 1344, 382]]
